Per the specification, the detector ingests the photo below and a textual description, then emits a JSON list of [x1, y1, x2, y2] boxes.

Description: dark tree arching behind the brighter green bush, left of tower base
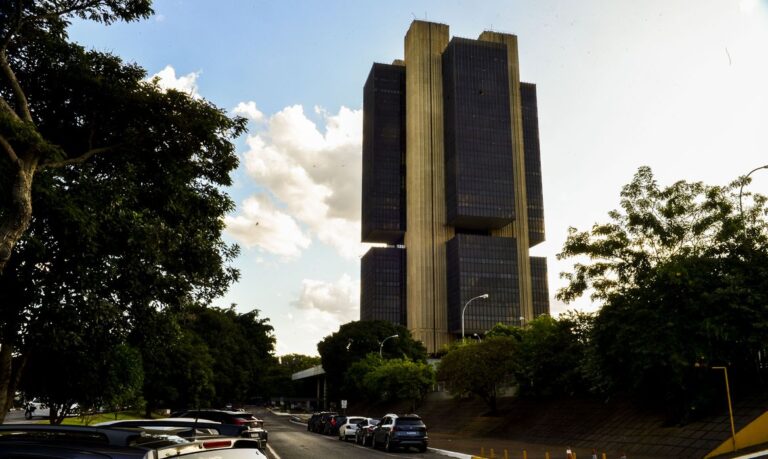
[[317, 320, 427, 398]]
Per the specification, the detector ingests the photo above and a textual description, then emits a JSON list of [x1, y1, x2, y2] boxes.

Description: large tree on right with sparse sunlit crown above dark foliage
[[558, 168, 768, 422]]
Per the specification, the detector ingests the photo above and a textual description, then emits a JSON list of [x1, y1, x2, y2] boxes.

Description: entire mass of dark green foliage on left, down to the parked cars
[[0, 0, 258, 420]]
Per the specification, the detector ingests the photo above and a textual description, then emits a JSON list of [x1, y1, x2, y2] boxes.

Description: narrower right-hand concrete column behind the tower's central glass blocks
[[479, 32, 533, 322]]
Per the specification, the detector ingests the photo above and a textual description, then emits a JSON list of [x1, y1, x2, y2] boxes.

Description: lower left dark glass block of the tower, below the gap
[[360, 247, 406, 325]]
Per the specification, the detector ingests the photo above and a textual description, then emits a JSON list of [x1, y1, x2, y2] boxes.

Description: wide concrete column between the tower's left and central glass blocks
[[405, 21, 453, 352]]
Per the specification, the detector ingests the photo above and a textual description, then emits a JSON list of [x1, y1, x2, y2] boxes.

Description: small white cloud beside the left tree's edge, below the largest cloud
[[224, 195, 311, 260]]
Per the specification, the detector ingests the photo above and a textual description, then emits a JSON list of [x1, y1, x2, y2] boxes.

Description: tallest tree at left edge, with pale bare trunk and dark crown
[[0, 0, 245, 419]]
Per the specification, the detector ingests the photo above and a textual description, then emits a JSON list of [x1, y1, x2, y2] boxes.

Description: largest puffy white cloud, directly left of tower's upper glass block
[[228, 102, 366, 259]]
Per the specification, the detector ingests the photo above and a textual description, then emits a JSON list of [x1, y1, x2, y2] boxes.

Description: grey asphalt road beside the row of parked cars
[[254, 410, 445, 459]]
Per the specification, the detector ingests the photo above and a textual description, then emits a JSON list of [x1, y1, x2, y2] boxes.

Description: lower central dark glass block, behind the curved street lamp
[[446, 234, 520, 334]]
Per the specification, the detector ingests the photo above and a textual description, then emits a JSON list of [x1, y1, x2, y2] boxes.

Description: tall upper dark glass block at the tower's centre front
[[443, 38, 514, 229]]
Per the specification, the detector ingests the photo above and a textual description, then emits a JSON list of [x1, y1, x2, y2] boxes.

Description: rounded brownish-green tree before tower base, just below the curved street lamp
[[437, 337, 519, 414]]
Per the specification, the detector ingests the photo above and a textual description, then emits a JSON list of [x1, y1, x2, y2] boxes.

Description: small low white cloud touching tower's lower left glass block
[[293, 274, 360, 323]]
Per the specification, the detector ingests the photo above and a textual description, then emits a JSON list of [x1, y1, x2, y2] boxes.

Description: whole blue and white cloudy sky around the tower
[[71, 0, 768, 354]]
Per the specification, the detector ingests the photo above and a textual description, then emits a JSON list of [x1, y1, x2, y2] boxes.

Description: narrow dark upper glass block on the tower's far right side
[[520, 83, 546, 248]]
